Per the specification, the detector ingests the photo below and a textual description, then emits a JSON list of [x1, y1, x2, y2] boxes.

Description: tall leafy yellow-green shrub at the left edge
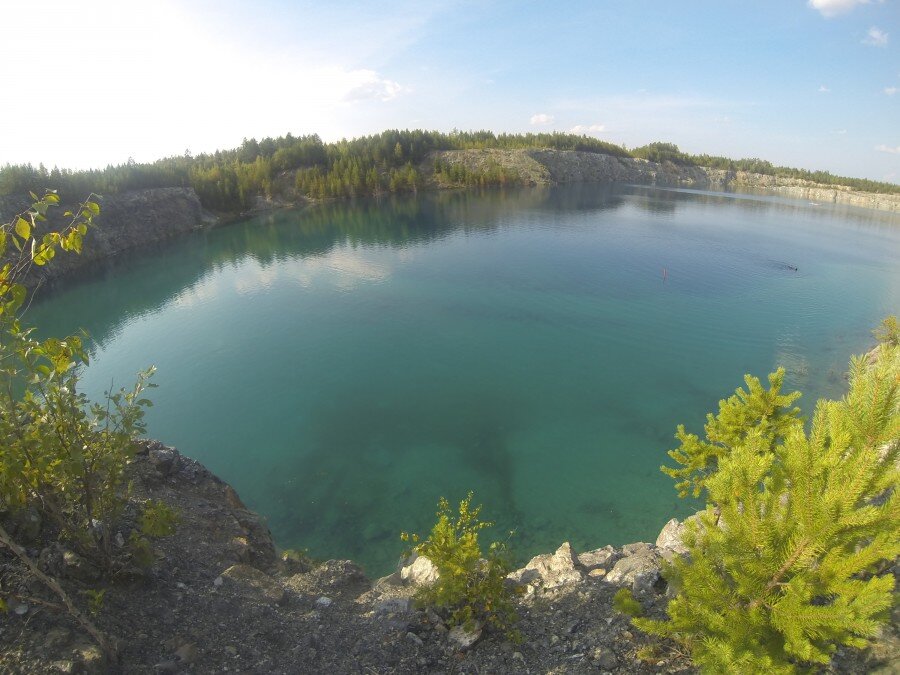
[[0, 193, 153, 571]]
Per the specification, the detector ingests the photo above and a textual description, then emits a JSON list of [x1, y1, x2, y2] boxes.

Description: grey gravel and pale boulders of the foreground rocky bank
[[0, 441, 900, 673]]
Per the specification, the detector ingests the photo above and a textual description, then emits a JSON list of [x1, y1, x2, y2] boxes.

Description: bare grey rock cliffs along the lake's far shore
[[0, 149, 900, 287]]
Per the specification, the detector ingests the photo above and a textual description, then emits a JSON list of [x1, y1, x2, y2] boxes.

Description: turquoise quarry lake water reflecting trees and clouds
[[28, 185, 900, 576]]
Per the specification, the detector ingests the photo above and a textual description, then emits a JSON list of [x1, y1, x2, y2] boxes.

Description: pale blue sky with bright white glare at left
[[0, 0, 900, 182]]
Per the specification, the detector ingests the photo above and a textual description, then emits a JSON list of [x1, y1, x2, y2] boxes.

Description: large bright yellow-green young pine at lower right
[[634, 346, 900, 673]]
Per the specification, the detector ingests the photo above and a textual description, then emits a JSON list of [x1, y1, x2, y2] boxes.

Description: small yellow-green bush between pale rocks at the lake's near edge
[[401, 492, 519, 641]]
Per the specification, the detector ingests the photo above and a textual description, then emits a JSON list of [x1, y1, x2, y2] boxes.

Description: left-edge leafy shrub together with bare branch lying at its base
[[0, 192, 175, 655]]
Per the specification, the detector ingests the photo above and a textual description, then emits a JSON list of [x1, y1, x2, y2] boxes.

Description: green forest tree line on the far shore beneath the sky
[[0, 129, 900, 212]]
